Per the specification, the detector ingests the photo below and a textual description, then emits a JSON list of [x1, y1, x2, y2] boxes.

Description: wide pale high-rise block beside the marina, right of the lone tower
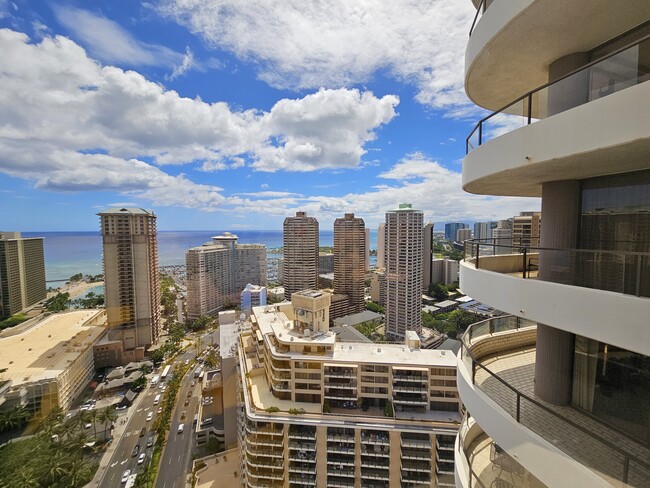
[[185, 232, 266, 320]]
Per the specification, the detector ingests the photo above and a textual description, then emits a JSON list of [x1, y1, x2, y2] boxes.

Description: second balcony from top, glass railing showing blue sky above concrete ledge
[[463, 38, 650, 196]]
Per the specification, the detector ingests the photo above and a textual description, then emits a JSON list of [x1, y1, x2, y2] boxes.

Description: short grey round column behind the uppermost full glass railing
[[548, 52, 589, 116]]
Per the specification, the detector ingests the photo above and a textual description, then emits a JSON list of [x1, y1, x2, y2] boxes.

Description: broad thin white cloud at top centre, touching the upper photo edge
[[158, 0, 475, 111]]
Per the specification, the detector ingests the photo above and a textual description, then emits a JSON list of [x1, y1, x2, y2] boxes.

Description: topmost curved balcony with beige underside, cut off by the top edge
[[465, 0, 650, 110]]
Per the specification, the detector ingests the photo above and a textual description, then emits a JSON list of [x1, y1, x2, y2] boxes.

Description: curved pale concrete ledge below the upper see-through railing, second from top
[[463, 82, 650, 197]]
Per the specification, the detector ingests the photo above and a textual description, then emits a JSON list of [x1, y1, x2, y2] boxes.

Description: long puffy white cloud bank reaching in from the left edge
[[0, 29, 398, 208]]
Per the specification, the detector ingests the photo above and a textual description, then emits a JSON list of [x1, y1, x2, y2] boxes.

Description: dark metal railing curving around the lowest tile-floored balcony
[[461, 316, 650, 486]]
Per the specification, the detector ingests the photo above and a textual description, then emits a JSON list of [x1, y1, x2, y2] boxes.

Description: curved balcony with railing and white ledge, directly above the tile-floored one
[[460, 239, 650, 355]]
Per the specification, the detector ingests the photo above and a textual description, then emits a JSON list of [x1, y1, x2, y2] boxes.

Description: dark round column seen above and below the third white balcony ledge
[[535, 180, 580, 405]]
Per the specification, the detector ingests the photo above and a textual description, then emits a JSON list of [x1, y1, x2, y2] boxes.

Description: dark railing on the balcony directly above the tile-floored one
[[464, 238, 650, 297]]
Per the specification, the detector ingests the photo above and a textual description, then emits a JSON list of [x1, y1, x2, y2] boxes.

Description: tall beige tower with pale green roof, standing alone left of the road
[[98, 208, 161, 352]]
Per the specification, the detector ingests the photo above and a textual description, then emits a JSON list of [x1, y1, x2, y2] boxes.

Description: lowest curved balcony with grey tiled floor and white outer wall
[[458, 316, 650, 487]]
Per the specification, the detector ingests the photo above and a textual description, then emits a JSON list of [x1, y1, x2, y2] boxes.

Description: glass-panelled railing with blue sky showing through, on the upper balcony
[[465, 35, 650, 154]]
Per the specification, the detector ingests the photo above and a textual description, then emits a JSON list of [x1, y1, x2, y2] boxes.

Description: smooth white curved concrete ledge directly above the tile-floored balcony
[[460, 262, 650, 356]]
